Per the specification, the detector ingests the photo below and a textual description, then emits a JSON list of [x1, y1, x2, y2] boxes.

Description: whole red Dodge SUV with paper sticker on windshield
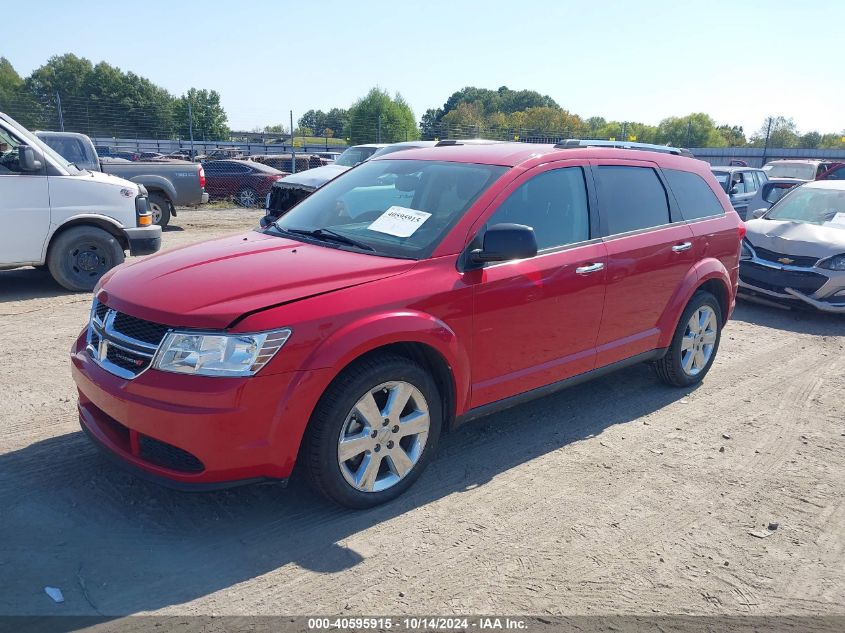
[[72, 143, 744, 507]]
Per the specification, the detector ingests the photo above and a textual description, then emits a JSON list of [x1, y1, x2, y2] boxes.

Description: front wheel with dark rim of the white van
[[47, 226, 123, 292]]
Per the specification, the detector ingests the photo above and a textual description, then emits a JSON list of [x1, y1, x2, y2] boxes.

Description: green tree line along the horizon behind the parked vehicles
[[0, 54, 845, 149]]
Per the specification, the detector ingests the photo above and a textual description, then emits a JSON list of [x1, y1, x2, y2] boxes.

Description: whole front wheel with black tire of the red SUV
[[301, 354, 442, 508]]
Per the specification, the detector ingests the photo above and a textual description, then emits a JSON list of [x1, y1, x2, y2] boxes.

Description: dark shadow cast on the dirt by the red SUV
[[0, 365, 691, 615]]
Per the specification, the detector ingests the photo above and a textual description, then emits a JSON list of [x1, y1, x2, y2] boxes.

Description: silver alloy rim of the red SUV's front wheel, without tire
[[337, 381, 431, 492]]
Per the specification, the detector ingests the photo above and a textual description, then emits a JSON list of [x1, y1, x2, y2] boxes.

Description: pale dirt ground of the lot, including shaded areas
[[0, 210, 845, 615]]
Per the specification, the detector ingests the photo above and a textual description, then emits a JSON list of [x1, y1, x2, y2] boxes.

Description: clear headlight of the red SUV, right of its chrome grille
[[153, 329, 291, 376]]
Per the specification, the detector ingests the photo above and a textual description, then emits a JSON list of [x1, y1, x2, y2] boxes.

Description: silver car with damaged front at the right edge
[[739, 180, 845, 314]]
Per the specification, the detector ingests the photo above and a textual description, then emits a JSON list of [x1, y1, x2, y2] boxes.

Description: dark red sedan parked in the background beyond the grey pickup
[[203, 160, 289, 208]]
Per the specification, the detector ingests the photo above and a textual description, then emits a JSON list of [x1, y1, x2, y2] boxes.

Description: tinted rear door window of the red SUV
[[596, 165, 670, 235]]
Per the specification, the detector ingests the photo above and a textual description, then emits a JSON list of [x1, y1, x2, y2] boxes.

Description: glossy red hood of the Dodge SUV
[[97, 232, 416, 329]]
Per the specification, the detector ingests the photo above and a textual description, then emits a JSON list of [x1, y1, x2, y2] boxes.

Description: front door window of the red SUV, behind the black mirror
[[487, 167, 590, 250]]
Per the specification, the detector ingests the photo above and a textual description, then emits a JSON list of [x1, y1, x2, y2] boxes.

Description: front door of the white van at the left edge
[[0, 127, 50, 264]]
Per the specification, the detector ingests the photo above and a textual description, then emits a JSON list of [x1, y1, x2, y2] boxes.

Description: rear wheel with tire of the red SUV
[[654, 290, 722, 387]]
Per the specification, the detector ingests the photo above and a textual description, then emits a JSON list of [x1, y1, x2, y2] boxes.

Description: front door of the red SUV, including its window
[[466, 161, 607, 407]]
